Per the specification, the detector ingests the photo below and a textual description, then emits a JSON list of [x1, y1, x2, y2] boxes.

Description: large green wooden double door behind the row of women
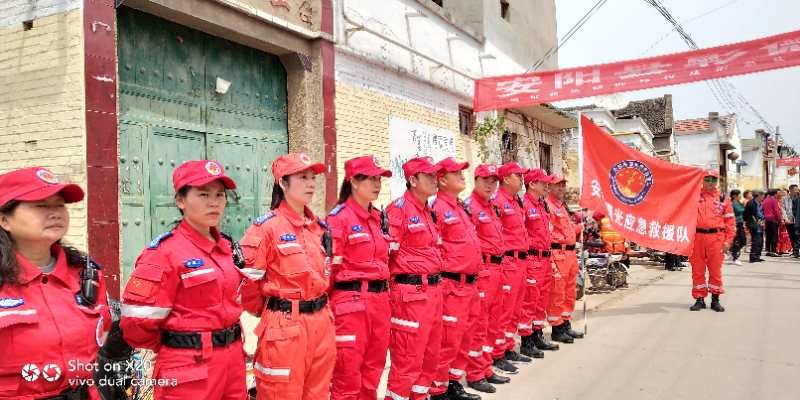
[[117, 7, 288, 282]]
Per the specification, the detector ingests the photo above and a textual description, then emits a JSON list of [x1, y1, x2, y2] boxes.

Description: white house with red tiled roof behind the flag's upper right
[[674, 112, 742, 190]]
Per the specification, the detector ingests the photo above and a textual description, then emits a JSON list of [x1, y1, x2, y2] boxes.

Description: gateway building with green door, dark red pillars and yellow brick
[[0, 0, 336, 294]]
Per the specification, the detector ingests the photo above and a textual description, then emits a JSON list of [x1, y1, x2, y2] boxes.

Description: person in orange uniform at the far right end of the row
[[546, 175, 583, 343]]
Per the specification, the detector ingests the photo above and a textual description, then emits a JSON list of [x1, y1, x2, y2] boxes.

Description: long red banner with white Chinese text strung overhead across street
[[474, 31, 800, 111]]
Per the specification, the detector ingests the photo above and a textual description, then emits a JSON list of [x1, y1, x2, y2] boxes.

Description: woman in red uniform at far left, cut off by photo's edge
[[0, 167, 111, 399]]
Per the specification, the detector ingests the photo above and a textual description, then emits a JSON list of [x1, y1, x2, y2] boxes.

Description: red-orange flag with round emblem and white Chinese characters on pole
[[580, 116, 705, 255]]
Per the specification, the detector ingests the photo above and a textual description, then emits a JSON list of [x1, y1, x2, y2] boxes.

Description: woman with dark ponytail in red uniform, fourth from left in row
[[328, 156, 392, 400]]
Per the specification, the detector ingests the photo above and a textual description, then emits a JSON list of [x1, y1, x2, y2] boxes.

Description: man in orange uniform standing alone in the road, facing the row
[[689, 171, 736, 312]]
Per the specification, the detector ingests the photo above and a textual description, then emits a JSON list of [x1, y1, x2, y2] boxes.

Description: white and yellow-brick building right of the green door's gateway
[[334, 0, 575, 204]]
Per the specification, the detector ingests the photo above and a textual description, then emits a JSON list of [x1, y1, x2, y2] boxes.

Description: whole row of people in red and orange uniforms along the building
[[0, 153, 727, 400]]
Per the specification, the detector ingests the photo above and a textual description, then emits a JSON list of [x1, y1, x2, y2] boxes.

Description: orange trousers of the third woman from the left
[[253, 300, 336, 400]]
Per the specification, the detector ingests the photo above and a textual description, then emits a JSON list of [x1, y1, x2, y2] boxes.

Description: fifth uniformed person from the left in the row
[[386, 157, 442, 400]]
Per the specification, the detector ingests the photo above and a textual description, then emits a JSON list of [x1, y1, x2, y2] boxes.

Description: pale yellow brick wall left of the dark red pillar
[[0, 7, 86, 248]]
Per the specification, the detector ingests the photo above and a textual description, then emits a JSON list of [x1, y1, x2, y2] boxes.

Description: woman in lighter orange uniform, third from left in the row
[[241, 153, 336, 400]]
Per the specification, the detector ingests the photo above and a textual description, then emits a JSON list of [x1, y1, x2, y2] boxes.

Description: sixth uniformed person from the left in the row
[[430, 157, 483, 400]]
